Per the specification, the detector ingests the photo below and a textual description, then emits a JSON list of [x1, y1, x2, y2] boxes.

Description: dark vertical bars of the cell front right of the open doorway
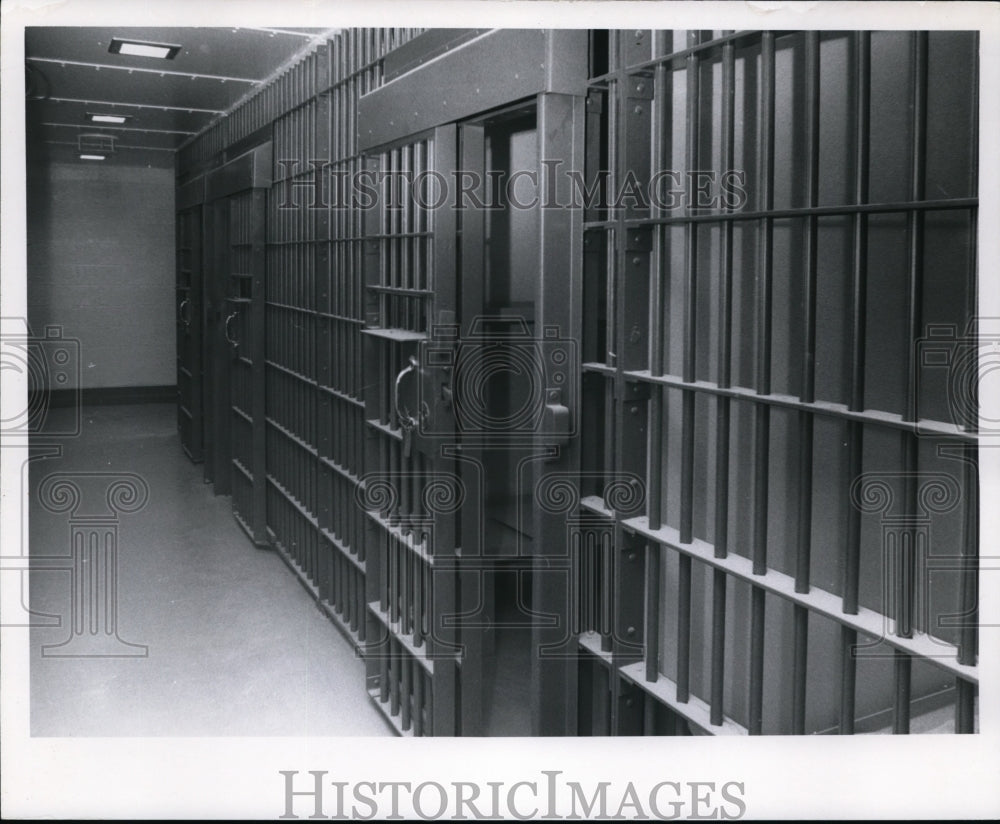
[[585, 32, 978, 734]]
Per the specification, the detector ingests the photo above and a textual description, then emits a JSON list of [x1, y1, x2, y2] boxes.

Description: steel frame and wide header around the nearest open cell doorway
[[358, 30, 588, 735]]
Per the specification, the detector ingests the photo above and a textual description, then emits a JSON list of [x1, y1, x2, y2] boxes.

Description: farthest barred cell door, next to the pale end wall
[[176, 205, 203, 462]]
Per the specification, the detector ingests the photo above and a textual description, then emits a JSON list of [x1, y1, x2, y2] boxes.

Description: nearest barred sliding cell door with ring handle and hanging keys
[[363, 125, 465, 735]]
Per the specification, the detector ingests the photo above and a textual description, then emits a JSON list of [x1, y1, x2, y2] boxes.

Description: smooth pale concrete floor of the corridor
[[30, 404, 392, 736]]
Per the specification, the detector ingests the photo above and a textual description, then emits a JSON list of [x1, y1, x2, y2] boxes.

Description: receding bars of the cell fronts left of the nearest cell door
[[178, 28, 425, 684]]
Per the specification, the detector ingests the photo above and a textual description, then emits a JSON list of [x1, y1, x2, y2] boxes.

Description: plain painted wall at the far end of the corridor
[[27, 161, 176, 389]]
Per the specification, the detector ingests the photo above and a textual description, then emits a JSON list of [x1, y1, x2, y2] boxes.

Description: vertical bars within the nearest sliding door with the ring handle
[[358, 129, 436, 736]]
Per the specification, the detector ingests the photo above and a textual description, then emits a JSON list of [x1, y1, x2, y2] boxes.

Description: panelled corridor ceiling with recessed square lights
[[25, 26, 328, 166]]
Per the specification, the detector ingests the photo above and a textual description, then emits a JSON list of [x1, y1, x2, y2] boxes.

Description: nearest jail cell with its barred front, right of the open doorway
[[583, 31, 978, 734]]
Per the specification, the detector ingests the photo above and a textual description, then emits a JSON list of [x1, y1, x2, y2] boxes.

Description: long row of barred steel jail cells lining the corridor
[[170, 29, 978, 735]]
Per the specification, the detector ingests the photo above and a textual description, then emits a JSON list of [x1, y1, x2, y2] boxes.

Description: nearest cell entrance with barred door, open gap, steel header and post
[[359, 31, 585, 735]]
